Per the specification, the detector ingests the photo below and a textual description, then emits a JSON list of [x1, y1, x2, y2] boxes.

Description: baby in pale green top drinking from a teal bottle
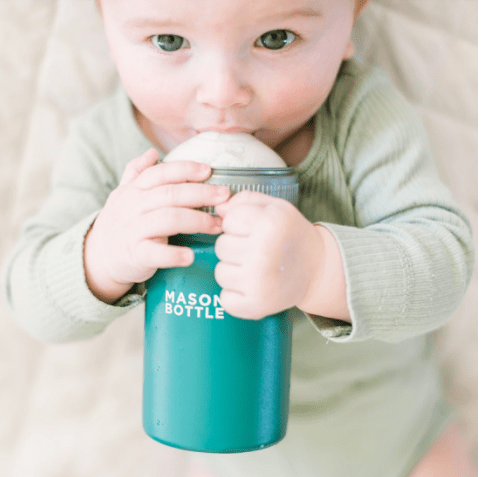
[[3, 0, 473, 477]]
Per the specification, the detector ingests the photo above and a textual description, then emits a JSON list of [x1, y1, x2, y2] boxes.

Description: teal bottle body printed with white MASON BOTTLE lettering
[[143, 235, 292, 452]]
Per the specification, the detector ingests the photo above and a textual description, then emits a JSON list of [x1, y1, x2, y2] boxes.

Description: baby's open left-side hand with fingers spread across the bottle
[[84, 149, 230, 303]]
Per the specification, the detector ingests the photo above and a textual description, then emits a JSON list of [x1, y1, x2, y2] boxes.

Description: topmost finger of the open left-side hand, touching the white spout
[[136, 161, 211, 190]]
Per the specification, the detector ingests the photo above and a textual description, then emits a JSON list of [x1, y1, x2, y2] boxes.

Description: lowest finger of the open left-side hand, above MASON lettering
[[135, 240, 194, 269]]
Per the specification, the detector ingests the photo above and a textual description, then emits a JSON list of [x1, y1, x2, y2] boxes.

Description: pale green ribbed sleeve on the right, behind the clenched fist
[[310, 65, 474, 342]]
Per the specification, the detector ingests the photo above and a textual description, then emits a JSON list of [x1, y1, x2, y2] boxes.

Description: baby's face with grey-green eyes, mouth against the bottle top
[[101, 0, 355, 152]]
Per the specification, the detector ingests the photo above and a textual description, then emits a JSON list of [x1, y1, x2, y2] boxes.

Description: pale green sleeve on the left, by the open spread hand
[[5, 113, 143, 342]]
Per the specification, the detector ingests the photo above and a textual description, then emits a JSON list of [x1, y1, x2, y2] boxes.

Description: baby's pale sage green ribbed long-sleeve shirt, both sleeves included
[[6, 60, 474, 477]]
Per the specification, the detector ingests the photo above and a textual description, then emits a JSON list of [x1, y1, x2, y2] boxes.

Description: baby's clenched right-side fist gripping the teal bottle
[[215, 191, 323, 319]]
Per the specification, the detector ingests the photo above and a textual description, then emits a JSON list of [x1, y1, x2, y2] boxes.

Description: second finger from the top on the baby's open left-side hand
[[142, 183, 230, 212]]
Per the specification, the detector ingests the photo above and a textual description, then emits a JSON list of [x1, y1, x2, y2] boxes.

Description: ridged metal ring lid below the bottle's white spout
[[202, 167, 299, 214]]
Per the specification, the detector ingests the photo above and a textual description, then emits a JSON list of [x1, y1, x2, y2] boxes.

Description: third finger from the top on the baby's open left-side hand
[[139, 207, 222, 238]]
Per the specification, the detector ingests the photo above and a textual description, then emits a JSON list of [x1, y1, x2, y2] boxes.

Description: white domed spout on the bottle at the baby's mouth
[[163, 131, 287, 168]]
